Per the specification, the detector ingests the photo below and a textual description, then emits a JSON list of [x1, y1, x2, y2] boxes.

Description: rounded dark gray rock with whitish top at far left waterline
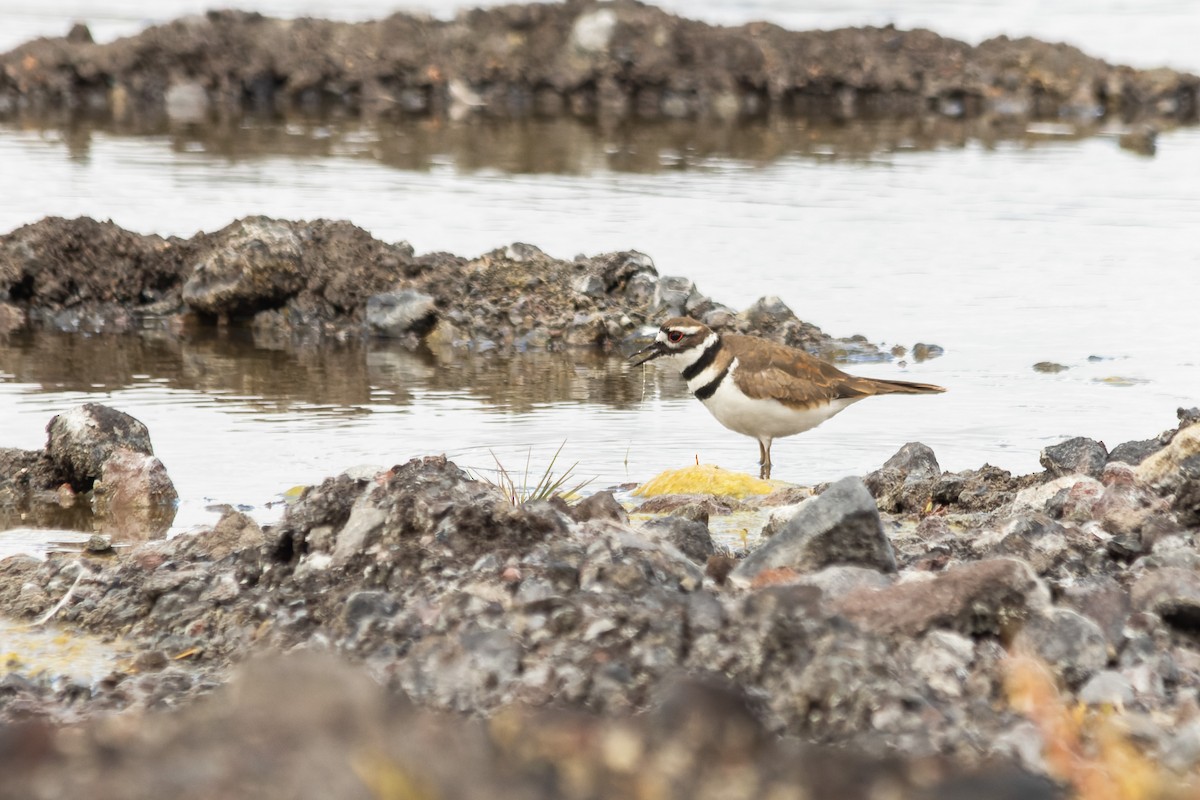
[[46, 403, 154, 491]]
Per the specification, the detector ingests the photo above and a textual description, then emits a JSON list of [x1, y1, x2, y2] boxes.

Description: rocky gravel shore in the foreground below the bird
[[0, 410, 1200, 796]]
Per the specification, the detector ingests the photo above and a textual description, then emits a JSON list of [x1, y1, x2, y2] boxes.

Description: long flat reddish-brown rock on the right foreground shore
[[835, 559, 1046, 636]]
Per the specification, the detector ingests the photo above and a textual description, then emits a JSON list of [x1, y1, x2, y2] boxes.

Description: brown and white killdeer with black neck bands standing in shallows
[[630, 317, 946, 479]]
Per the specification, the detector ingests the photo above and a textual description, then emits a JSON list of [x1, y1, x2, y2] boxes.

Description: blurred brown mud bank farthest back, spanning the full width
[[0, 1, 1200, 122]]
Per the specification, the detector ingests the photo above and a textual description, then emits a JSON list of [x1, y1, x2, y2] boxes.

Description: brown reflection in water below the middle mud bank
[[0, 329, 685, 412]]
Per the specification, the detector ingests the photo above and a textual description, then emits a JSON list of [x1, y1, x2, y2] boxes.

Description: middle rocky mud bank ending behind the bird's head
[[0, 217, 907, 360]]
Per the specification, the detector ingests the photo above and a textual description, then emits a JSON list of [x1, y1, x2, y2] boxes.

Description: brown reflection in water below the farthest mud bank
[[0, 115, 1102, 175]]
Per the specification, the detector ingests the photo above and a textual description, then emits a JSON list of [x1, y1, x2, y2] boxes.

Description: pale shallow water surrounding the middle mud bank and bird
[[0, 2, 1200, 544]]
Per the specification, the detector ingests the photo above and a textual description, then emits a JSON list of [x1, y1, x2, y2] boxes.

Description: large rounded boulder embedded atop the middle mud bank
[[182, 217, 305, 314]]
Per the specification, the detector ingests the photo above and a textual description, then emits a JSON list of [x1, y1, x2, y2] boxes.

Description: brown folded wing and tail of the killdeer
[[722, 333, 946, 408]]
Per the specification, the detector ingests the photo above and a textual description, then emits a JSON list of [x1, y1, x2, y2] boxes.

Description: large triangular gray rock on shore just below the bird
[[730, 477, 896, 585]]
